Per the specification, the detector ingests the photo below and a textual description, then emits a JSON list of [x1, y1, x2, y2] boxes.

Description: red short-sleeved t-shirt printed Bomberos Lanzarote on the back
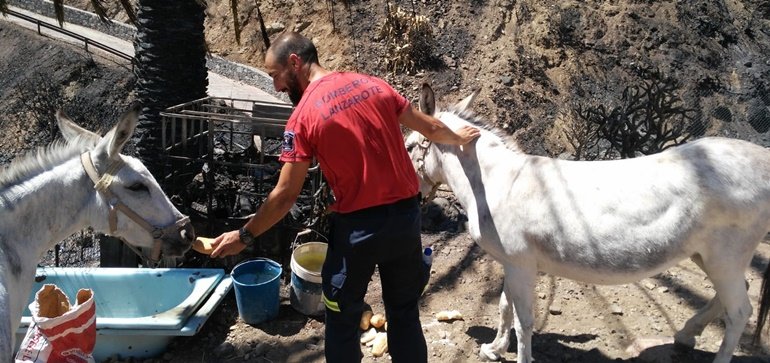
[[280, 72, 419, 213]]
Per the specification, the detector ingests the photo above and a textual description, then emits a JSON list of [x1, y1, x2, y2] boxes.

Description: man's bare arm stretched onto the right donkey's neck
[[398, 106, 479, 145]]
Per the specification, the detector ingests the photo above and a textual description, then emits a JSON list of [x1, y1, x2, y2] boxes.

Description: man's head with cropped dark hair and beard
[[265, 32, 318, 105]]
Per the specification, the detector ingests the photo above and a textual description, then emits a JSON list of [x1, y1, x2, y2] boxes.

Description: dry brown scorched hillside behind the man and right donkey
[[12, 0, 770, 156]]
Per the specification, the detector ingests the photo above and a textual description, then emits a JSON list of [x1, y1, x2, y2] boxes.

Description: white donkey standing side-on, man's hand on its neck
[[406, 86, 770, 363]]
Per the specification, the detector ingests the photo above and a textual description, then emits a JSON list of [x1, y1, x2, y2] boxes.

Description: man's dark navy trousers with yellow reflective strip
[[322, 197, 428, 363]]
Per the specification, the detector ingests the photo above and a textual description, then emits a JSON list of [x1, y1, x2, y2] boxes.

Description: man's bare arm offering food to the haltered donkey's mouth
[[211, 161, 310, 257]]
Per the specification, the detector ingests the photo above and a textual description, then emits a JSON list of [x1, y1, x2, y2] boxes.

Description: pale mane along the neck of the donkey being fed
[[0, 136, 96, 191]]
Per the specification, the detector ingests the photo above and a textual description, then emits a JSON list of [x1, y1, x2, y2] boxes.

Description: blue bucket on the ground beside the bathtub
[[230, 258, 282, 324]]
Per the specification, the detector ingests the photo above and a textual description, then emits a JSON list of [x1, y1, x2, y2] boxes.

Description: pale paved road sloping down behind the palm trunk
[[0, 6, 284, 107]]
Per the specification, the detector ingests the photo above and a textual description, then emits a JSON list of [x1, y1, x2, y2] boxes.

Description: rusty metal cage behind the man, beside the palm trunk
[[159, 97, 329, 266]]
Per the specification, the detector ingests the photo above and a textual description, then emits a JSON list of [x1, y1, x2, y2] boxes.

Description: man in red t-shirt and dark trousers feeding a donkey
[[211, 32, 479, 363]]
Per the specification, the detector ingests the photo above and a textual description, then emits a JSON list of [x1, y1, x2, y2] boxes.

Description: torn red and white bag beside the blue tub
[[16, 284, 96, 363]]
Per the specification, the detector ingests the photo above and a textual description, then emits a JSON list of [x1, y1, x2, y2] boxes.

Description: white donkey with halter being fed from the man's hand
[[0, 109, 195, 362]]
